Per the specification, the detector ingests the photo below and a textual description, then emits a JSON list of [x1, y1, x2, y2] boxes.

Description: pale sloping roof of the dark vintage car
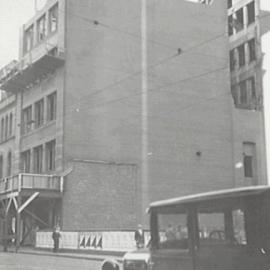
[[148, 186, 270, 211]]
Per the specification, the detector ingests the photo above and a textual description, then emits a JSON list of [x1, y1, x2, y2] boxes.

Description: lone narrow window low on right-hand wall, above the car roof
[[243, 142, 255, 178]]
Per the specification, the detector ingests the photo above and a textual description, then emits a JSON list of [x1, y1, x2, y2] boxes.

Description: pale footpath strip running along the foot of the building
[[0, 247, 125, 263]]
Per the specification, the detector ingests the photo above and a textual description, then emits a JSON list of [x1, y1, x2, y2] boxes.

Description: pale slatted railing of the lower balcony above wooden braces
[[0, 173, 63, 194]]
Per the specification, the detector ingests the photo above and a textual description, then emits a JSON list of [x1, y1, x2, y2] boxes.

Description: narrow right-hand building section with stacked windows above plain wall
[[227, 0, 266, 186]]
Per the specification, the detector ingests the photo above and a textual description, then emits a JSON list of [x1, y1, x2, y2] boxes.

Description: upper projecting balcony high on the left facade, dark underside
[[0, 44, 65, 92]]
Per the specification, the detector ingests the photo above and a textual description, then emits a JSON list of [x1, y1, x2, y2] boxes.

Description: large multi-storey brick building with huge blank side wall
[[0, 0, 266, 248]]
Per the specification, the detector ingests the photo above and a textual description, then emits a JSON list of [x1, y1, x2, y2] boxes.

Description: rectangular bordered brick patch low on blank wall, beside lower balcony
[[63, 161, 137, 231]]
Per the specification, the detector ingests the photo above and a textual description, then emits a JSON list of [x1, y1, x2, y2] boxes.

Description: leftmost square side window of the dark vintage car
[[158, 214, 188, 250]]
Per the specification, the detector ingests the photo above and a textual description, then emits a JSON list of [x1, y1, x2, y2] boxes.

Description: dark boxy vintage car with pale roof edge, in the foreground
[[121, 186, 270, 270]]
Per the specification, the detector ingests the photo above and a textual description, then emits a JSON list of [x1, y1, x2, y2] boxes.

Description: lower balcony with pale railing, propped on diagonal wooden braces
[[0, 173, 63, 197]]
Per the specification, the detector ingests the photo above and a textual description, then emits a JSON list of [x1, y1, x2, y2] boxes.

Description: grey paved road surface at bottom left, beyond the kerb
[[0, 252, 101, 270]]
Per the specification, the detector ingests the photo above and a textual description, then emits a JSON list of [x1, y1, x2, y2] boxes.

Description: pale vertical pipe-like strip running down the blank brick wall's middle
[[141, 0, 149, 226]]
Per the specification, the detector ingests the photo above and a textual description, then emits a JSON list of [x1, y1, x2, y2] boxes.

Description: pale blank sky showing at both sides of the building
[[0, 0, 270, 181]]
